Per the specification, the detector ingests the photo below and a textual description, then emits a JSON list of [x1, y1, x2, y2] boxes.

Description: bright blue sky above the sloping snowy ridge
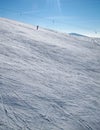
[[0, 0, 100, 37]]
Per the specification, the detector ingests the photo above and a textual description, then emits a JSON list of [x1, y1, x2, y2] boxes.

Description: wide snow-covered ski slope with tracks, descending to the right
[[0, 18, 100, 130]]
